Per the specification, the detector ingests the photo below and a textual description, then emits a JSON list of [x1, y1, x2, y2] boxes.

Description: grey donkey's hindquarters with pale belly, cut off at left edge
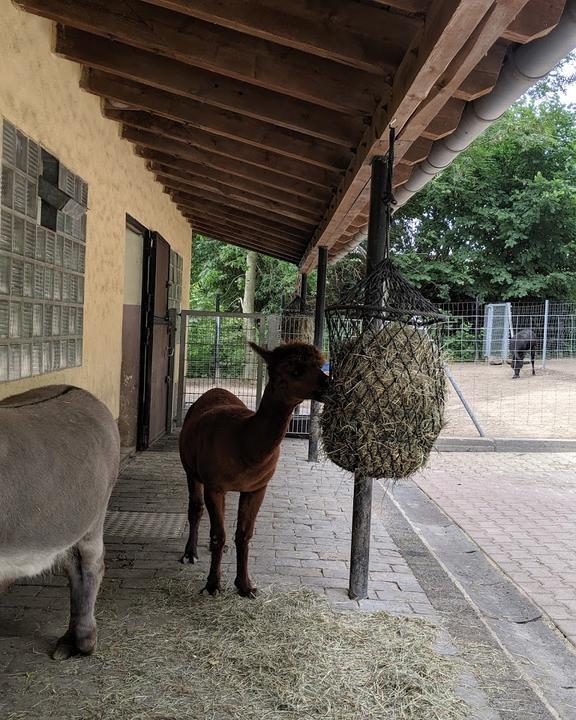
[[0, 385, 120, 660]]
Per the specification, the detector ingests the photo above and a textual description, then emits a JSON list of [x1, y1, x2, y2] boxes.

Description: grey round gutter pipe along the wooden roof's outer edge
[[342, 0, 576, 258]]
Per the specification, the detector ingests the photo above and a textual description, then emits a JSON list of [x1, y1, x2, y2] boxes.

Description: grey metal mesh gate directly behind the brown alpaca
[[177, 310, 313, 437]]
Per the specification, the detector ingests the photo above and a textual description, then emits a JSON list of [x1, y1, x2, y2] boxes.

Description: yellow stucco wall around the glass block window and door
[[0, 0, 192, 417]]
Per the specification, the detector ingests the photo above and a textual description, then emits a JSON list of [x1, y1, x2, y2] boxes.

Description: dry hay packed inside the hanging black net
[[321, 322, 445, 478]]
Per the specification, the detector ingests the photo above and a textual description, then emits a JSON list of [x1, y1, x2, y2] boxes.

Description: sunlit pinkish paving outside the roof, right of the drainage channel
[[415, 453, 576, 644]]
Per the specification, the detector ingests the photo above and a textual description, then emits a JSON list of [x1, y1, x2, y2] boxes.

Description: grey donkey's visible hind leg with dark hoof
[[52, 524, 104, 660]]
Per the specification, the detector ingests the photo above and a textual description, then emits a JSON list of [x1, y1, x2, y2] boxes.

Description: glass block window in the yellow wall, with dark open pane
[[0, 120, 88, 382]]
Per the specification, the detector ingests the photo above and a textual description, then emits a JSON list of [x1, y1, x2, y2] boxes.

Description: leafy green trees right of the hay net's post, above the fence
[[392, 98, 576, 300]]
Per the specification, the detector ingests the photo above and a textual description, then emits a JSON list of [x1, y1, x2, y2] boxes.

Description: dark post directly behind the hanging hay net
[[348, 149, 393, 600]]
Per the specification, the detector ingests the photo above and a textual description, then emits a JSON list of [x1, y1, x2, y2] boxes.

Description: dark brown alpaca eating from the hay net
[[180, 343, 328, 597]]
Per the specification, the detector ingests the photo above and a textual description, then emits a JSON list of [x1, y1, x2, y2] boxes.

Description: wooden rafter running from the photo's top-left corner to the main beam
[[17, 0, 382, 114]]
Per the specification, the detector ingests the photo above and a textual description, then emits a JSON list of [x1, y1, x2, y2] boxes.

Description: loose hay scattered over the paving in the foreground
[[11, 580, 466, 720]]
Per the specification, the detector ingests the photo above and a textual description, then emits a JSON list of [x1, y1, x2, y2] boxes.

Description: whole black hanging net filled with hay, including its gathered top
[[321, 259, 446, 478]]
